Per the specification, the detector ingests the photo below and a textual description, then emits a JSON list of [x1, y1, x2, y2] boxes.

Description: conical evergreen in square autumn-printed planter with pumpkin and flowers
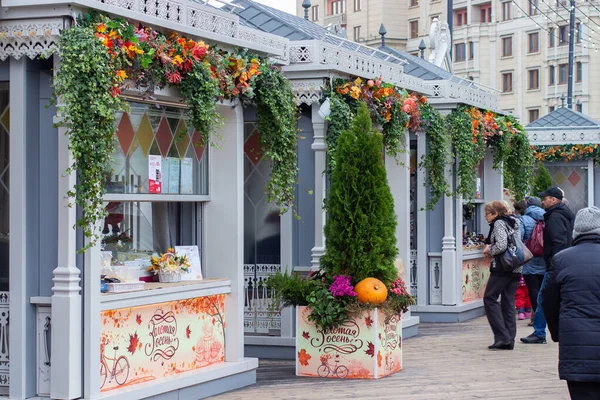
[[267, 103, 414, 378]]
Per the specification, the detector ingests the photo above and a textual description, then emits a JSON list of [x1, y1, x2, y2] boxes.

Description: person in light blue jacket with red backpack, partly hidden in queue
[[514, 197, 546, 326]]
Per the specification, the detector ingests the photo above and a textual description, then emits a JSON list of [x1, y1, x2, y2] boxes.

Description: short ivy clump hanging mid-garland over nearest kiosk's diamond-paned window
[[180, 63, 223, 146]]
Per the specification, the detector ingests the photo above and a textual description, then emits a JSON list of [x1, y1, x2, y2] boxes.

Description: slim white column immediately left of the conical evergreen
[[311, 103, 327, 270]]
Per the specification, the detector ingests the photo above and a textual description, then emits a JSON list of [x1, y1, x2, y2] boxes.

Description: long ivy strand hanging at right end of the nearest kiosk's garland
[[255, 65, 298, 217]]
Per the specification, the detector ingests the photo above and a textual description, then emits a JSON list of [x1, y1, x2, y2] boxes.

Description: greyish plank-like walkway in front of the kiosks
[[212, 317, 569, 400]]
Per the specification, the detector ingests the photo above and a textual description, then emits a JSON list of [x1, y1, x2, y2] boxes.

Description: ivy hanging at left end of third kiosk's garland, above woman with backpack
[[446, 107, 485, 200]]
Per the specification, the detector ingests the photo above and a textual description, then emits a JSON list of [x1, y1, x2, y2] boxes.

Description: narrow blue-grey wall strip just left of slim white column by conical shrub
[[292, 104, 315, 267]]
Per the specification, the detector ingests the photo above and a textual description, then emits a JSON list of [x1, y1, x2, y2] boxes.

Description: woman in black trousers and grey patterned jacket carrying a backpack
[[483, 200, 523, 350]]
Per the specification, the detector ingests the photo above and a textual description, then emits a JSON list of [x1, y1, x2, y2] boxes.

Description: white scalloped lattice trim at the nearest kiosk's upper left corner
[[0, 18, 65, 60]]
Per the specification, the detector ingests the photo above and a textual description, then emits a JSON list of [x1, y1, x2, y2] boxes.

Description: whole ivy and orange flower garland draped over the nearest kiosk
[[54, 13, 297, 251]]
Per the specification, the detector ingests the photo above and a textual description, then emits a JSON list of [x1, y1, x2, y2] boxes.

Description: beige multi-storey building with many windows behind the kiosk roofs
[[297, 0, 600, 123]]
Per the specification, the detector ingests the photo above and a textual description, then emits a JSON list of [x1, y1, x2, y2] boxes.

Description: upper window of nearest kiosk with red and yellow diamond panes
[[106, 103, 208, 195]]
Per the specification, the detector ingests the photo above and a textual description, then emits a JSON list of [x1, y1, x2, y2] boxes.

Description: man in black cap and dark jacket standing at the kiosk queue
[[521, 186, 575, 344]]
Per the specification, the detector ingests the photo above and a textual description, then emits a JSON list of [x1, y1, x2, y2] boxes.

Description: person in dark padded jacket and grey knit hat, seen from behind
[[542, 207, 600, 400]]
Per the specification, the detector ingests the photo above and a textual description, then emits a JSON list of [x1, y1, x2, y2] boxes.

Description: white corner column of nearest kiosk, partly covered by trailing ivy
[[50, 55, 82, 399]]
